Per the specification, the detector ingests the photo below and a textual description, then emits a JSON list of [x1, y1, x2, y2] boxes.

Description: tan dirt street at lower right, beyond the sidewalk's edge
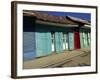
[[58, 53, 91, 67]]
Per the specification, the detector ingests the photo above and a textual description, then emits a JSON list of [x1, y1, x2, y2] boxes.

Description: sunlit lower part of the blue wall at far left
[[23, 32, 36, 60]]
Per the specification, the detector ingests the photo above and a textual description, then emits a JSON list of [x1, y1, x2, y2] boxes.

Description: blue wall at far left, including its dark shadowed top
[[23, 16, 36, 60]]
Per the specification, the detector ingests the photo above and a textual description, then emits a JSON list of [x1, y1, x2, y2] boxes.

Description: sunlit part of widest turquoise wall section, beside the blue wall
[[35, 32, 51, 57]]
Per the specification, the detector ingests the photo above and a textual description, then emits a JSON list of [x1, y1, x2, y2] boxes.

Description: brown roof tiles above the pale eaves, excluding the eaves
[[24, 11, 90, 25]]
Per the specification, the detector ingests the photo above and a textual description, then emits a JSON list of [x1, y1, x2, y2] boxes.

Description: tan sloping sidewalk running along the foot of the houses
[[23, 48, 90, 69]]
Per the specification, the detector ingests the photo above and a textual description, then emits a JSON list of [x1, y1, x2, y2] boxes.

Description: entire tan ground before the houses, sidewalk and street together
[[23, 48, 91, 69]]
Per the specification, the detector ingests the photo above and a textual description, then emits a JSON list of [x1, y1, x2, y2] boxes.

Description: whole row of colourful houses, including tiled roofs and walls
[[23, 11, 91, 60]]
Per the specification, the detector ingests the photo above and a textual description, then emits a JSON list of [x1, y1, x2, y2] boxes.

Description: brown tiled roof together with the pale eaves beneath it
[[23, 11, 90, 28]]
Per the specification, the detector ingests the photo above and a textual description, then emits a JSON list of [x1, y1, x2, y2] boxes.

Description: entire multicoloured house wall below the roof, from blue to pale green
[[23, 17, 91, 60]]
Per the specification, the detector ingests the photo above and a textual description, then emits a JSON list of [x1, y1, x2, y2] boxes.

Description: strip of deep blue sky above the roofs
[[40, 11, 91, 21]]
